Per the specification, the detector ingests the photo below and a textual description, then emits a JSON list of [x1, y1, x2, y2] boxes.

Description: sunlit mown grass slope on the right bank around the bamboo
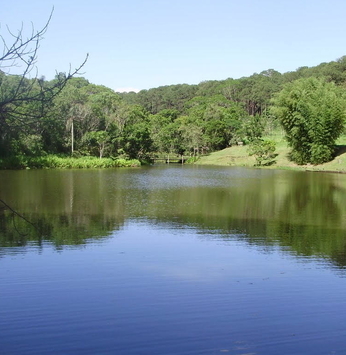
[[196, 133, 346, 173]]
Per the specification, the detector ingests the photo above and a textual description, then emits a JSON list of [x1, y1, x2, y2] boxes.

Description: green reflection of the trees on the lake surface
[[0, 166, 346, 269]]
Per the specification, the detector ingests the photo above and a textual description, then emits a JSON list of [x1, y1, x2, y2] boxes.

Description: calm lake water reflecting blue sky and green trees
[[0, 165, 346, 355]]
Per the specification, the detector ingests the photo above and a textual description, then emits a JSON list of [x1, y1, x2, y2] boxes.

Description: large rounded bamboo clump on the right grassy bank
[[272, 78, 346, 164]]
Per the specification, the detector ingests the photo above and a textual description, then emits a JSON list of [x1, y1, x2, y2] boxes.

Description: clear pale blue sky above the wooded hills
[[0, 0, 346, 90]]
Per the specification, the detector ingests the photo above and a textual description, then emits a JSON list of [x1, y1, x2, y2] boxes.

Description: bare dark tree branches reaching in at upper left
[[0, 8, 88, 133]]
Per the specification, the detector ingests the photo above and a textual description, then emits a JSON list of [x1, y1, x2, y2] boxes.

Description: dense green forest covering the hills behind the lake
[[0, 56, 346, 168]]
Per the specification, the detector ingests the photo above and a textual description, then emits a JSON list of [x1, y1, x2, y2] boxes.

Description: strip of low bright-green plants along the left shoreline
[[0, 155, 141, 169]]
